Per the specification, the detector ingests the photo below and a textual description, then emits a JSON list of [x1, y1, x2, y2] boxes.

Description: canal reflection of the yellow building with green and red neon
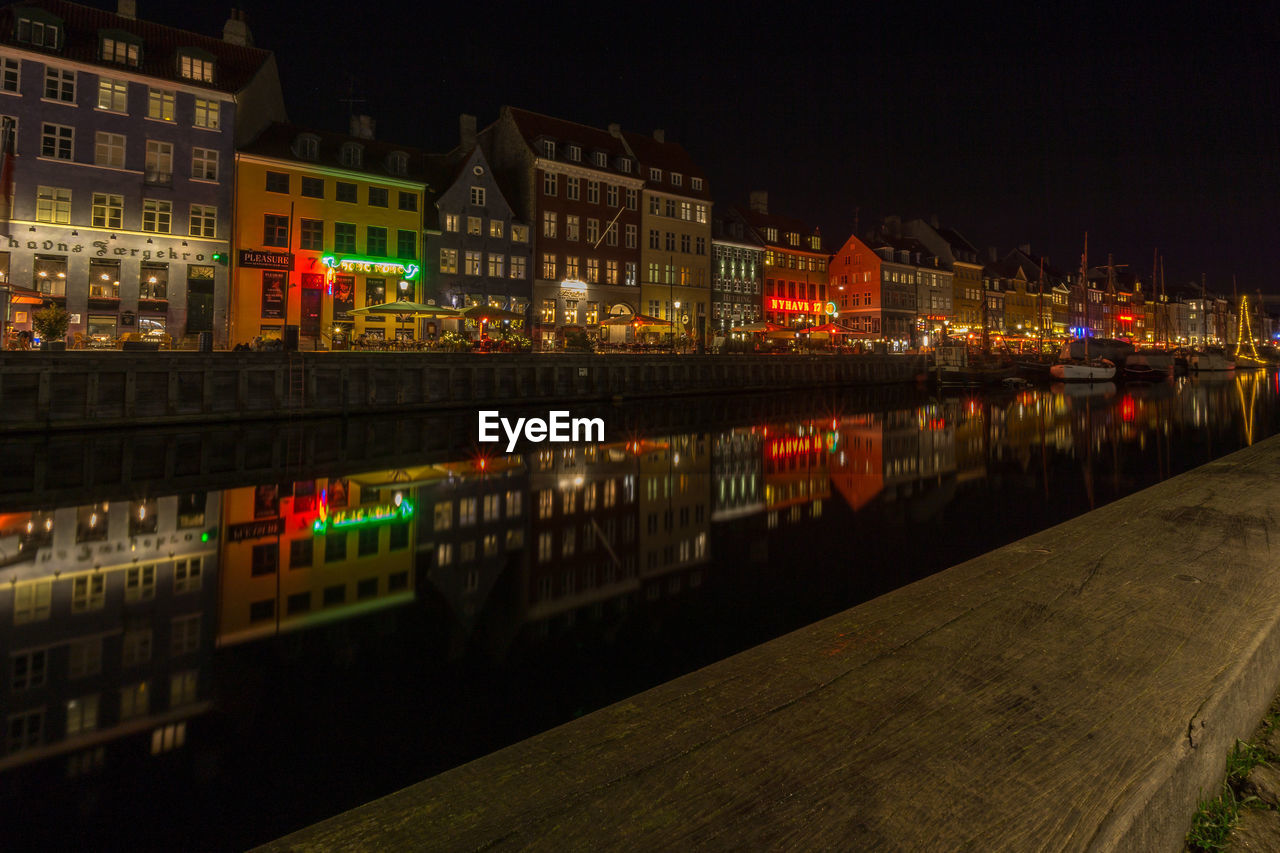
[[218, 473, 417, 646]]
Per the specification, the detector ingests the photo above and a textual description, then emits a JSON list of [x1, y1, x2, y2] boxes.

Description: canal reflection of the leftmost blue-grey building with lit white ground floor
[[0, 493, 219, 786]]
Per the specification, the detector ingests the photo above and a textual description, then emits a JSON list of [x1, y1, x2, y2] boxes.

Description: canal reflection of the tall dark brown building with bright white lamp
[[525, 442, 648, 621]]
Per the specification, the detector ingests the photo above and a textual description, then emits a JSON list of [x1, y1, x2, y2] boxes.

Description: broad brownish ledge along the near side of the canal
[[254, 438, 1280, 852]]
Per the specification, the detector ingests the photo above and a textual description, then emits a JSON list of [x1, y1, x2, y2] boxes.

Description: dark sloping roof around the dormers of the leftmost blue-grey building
[[0, 0, 271, 92]]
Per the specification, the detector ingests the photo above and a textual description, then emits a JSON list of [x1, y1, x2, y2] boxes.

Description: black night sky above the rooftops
[[107, 0, 1280, 292]]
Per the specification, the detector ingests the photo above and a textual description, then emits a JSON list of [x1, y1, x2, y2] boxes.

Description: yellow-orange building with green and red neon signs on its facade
[[230, 117, 426, 348]]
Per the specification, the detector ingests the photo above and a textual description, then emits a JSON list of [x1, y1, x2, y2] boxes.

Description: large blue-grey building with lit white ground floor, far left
[[0, 0, 284, 346]]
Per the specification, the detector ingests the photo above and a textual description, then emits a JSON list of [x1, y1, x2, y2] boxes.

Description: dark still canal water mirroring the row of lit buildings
[[0, 373, 1280, 850]]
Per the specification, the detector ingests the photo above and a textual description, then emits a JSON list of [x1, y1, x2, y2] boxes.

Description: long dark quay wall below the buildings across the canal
[[0, 351, 925, 432]]
